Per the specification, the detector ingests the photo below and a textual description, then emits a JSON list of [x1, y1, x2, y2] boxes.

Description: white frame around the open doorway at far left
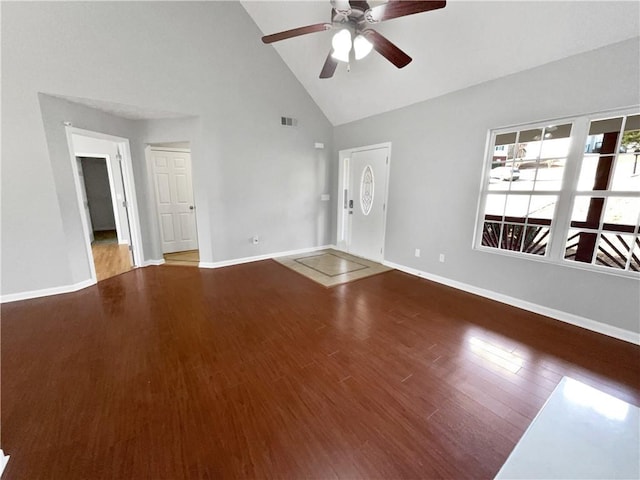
[[65, 125, 144, 283]]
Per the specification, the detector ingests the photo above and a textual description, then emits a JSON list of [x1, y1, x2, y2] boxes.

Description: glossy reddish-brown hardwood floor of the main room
[[1, 260, 640, 480]]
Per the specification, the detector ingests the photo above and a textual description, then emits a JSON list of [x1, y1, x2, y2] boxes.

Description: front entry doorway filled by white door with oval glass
[[337, 143, 391, 262]]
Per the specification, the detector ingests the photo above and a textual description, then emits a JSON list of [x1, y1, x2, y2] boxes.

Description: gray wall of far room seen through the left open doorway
[[81, 158, 116, 232]]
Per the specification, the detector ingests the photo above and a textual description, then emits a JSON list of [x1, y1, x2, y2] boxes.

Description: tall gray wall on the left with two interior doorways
[[1, 2, 333, 295]]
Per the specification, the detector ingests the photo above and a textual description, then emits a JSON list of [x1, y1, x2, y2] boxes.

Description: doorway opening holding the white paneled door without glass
[[149, 142, 200, 267]]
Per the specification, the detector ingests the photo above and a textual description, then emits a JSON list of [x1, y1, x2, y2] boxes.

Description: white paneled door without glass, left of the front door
[[151, 150, 198, 253]]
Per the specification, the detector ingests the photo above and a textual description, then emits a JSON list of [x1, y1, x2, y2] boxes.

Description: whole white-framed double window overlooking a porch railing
[[475, 110, 640, 272]]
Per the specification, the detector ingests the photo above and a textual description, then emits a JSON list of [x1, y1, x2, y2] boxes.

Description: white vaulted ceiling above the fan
[[241, 0, 640, 125]]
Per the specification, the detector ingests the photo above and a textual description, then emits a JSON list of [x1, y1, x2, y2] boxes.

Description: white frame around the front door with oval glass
[[336, 142, 391, 260]]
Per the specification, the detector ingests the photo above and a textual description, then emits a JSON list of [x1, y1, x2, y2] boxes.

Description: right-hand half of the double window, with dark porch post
[[564, 115, 640, 272]]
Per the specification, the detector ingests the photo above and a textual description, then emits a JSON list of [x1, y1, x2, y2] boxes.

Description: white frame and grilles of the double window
[[472, 105, 640, 278]]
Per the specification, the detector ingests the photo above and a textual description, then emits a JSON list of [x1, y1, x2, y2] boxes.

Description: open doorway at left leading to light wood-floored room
[[66, 126, 143, 281]]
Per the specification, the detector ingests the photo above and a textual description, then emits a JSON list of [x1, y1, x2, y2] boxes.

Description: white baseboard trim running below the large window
[[382, 261, 640, 345]]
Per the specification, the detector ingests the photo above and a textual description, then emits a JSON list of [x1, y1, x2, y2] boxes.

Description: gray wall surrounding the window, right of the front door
[[335, 39, 640, 332]]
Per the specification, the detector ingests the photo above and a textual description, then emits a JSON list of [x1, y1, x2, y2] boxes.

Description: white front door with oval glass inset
[[347, 147, 389, 261]]
